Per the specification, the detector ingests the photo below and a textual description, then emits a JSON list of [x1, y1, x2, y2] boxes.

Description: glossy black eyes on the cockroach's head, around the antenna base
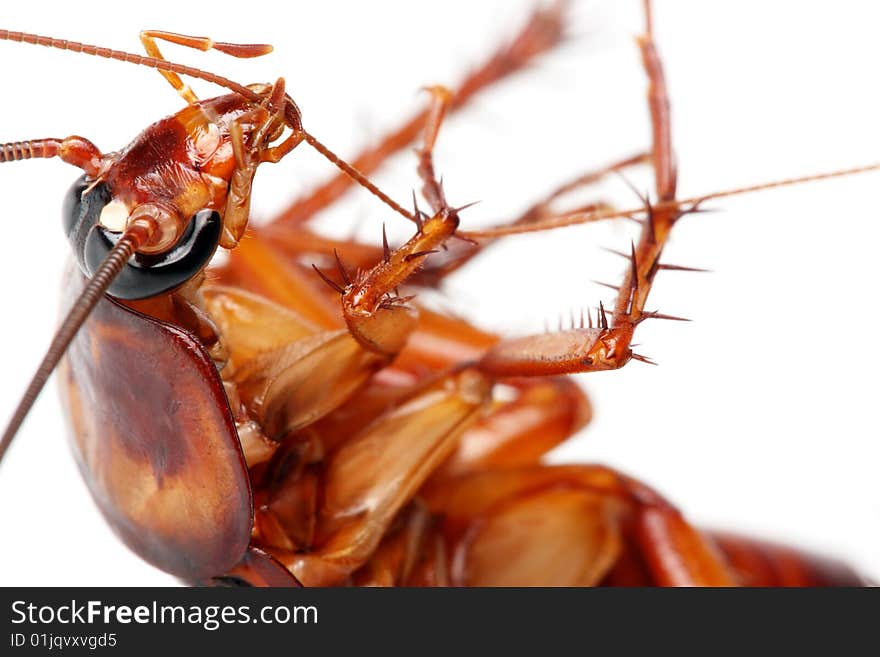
[[63, 176, 222, 299]]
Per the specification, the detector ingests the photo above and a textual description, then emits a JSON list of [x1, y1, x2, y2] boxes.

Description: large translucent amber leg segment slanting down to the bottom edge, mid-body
[[285, 368, 492, 586]]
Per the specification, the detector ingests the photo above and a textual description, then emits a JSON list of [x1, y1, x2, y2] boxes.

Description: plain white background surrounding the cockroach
[[0, 0, 880, 586]]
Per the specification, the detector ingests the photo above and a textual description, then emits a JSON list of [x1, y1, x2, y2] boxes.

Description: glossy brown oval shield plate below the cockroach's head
[[60, 275, 253, 581]]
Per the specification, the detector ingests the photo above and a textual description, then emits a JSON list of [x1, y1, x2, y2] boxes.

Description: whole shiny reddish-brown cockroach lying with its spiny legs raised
[[0, 4, 875, 586]]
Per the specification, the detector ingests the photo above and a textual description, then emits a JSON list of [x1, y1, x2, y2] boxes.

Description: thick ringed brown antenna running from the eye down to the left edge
[[0, 223, 150, 462]]
